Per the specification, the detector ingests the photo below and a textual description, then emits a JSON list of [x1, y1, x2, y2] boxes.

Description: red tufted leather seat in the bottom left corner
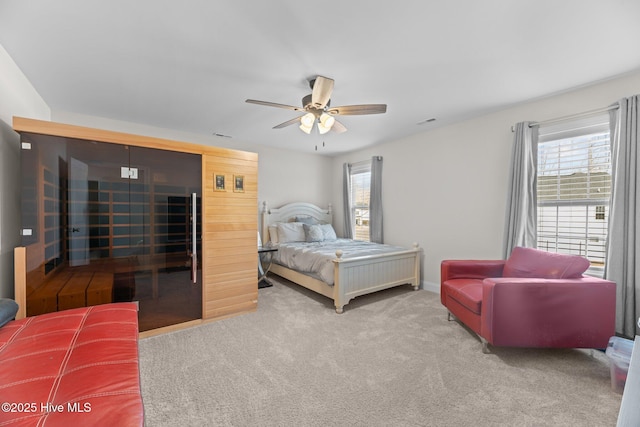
[[0, 303, 144, 426]]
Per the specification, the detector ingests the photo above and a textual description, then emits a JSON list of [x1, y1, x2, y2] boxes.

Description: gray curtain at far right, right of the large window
[[604, 95, 640, 338]]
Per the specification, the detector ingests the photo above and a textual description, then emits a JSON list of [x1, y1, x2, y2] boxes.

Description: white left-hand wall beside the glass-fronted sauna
[[0, 45, 51, 298]]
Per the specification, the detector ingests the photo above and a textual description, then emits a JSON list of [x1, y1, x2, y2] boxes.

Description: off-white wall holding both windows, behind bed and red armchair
[[333, 72, 640, 291]]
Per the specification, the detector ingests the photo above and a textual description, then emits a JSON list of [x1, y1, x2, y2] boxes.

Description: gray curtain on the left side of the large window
[[503, 122, 538, 259]]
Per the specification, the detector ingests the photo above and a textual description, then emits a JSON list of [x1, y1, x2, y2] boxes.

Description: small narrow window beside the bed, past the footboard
[[351, 161, 371, 242]]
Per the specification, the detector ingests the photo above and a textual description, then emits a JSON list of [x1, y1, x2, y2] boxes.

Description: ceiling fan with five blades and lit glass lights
[[246, 76, 387, 134]]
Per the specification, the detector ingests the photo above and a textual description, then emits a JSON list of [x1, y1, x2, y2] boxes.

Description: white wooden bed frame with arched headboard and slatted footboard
[[262, 202, 421, 313]]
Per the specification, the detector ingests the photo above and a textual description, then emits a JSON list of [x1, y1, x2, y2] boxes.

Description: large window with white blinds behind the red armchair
[[537, 115, 611, 271]]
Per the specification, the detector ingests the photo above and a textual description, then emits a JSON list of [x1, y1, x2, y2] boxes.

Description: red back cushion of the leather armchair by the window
[[503, 247, 589, 279]]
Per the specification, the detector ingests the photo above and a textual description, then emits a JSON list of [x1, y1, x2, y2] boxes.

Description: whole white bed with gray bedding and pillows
[[261, 202, 421, 314]]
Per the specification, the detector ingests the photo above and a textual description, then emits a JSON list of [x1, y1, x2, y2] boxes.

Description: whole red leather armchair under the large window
[[440, 247, 616, 353]]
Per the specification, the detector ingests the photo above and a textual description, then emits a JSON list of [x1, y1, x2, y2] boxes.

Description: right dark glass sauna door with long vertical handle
[[129, 147, 202, 330]]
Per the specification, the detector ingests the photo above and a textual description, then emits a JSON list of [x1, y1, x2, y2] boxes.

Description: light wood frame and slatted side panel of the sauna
[[13, 117, 258, 324]]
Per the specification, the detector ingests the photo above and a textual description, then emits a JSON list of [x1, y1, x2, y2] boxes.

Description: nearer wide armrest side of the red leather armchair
[[481, 276, 616, 348]]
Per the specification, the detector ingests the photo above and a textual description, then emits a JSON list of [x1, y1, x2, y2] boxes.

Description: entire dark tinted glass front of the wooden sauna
[[22, 133, 202, 330]]
